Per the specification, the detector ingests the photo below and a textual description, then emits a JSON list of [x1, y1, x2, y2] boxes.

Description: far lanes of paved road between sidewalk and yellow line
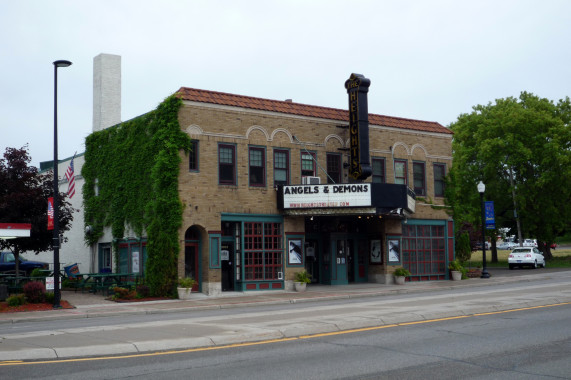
[[0, 270, 571, 360]]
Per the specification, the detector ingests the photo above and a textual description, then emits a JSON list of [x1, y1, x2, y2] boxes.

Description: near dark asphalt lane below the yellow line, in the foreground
[[0, 304, 571, 380]]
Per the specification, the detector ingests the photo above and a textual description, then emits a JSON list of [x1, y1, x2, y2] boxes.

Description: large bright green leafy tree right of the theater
[[446, 92, 571, 261]]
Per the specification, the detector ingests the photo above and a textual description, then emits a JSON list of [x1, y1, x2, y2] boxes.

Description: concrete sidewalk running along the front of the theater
[[0, 268, 571, 323]]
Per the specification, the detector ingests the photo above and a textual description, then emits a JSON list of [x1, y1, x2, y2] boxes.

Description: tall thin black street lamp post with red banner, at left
[[53, 60, 71, 309]]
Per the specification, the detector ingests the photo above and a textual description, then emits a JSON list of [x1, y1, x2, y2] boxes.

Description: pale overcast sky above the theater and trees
[[0, 0, 571, 165]]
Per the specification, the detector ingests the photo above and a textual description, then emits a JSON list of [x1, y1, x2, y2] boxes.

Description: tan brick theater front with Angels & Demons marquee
[[175, 87, 454, 295]]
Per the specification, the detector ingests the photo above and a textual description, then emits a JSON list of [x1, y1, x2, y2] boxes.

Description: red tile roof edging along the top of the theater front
[[177, 87, 452, 134]]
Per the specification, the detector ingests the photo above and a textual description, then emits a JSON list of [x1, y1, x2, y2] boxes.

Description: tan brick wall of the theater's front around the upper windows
[[179, 103, 452, 281]]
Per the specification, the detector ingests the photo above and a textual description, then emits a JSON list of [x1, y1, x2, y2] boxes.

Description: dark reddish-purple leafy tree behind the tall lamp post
[[0, 147, 73, 273]]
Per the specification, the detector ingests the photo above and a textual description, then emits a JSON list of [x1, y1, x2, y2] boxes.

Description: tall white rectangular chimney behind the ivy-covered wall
[[93, 54, 121, 132]]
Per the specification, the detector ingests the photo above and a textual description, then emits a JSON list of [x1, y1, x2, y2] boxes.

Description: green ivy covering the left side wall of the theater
[[81, 95, 191, 296]]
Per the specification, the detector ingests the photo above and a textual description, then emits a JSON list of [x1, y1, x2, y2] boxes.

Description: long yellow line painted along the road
[[0, 302, 571, 366]]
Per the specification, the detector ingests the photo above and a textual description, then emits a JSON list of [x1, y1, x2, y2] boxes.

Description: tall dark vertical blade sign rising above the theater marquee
[[345, 74, 372, 179]]
